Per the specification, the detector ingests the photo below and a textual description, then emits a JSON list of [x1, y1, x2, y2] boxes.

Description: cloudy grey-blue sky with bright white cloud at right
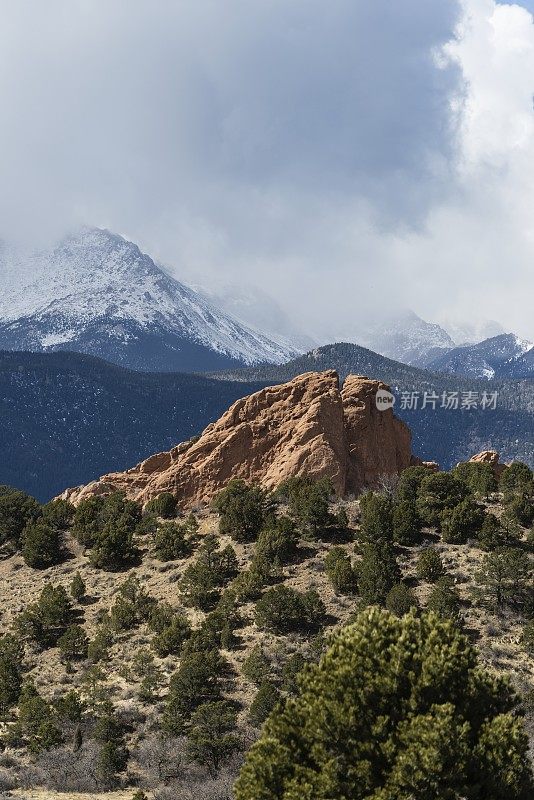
[[0, 0, 534, 339]]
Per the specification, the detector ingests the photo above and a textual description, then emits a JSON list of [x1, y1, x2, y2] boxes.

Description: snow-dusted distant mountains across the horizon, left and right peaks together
[[0, 223, 534, 378]]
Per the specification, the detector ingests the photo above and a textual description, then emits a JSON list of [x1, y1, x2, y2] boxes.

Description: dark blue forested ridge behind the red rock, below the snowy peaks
[[4, 344, 534, 500]]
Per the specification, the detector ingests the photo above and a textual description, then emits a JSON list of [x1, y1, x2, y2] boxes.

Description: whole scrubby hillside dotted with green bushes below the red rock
[[0, 463, 534, 800]]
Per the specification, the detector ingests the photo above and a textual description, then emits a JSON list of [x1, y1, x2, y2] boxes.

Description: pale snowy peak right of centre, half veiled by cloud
[[358, 311, 455, 367]]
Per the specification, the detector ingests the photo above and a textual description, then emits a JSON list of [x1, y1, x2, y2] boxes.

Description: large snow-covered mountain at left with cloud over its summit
[[0, 228, 298, 372]]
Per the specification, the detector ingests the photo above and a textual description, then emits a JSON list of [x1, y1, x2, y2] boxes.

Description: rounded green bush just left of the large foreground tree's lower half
[[187, 700, 239, 775]]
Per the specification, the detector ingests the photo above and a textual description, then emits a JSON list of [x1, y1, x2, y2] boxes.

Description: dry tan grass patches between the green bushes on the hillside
[[0, 501, 534, 800]]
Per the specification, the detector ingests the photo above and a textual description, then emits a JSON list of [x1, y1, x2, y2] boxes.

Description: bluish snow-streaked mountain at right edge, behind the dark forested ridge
[[429, 333, 534, 380]]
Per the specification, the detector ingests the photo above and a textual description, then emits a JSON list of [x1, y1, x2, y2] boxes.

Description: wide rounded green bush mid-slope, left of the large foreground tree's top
[[255, 585, 326, 633]]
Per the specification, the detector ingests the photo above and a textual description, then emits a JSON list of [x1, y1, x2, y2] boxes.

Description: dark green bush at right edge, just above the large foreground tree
[[473, 547, 532, 611]]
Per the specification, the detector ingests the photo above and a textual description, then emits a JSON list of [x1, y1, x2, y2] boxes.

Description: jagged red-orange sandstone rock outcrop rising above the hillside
[[62, 371, 418, 508]]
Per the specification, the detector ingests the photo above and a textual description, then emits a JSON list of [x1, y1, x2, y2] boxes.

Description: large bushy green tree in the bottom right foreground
[[235, 608, 534, 800]]
